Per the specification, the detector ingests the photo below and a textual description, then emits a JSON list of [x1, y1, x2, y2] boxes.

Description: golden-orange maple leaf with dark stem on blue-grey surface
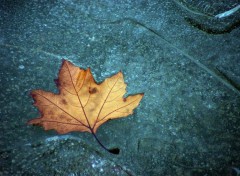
[[28, 60, 143, 153]]
